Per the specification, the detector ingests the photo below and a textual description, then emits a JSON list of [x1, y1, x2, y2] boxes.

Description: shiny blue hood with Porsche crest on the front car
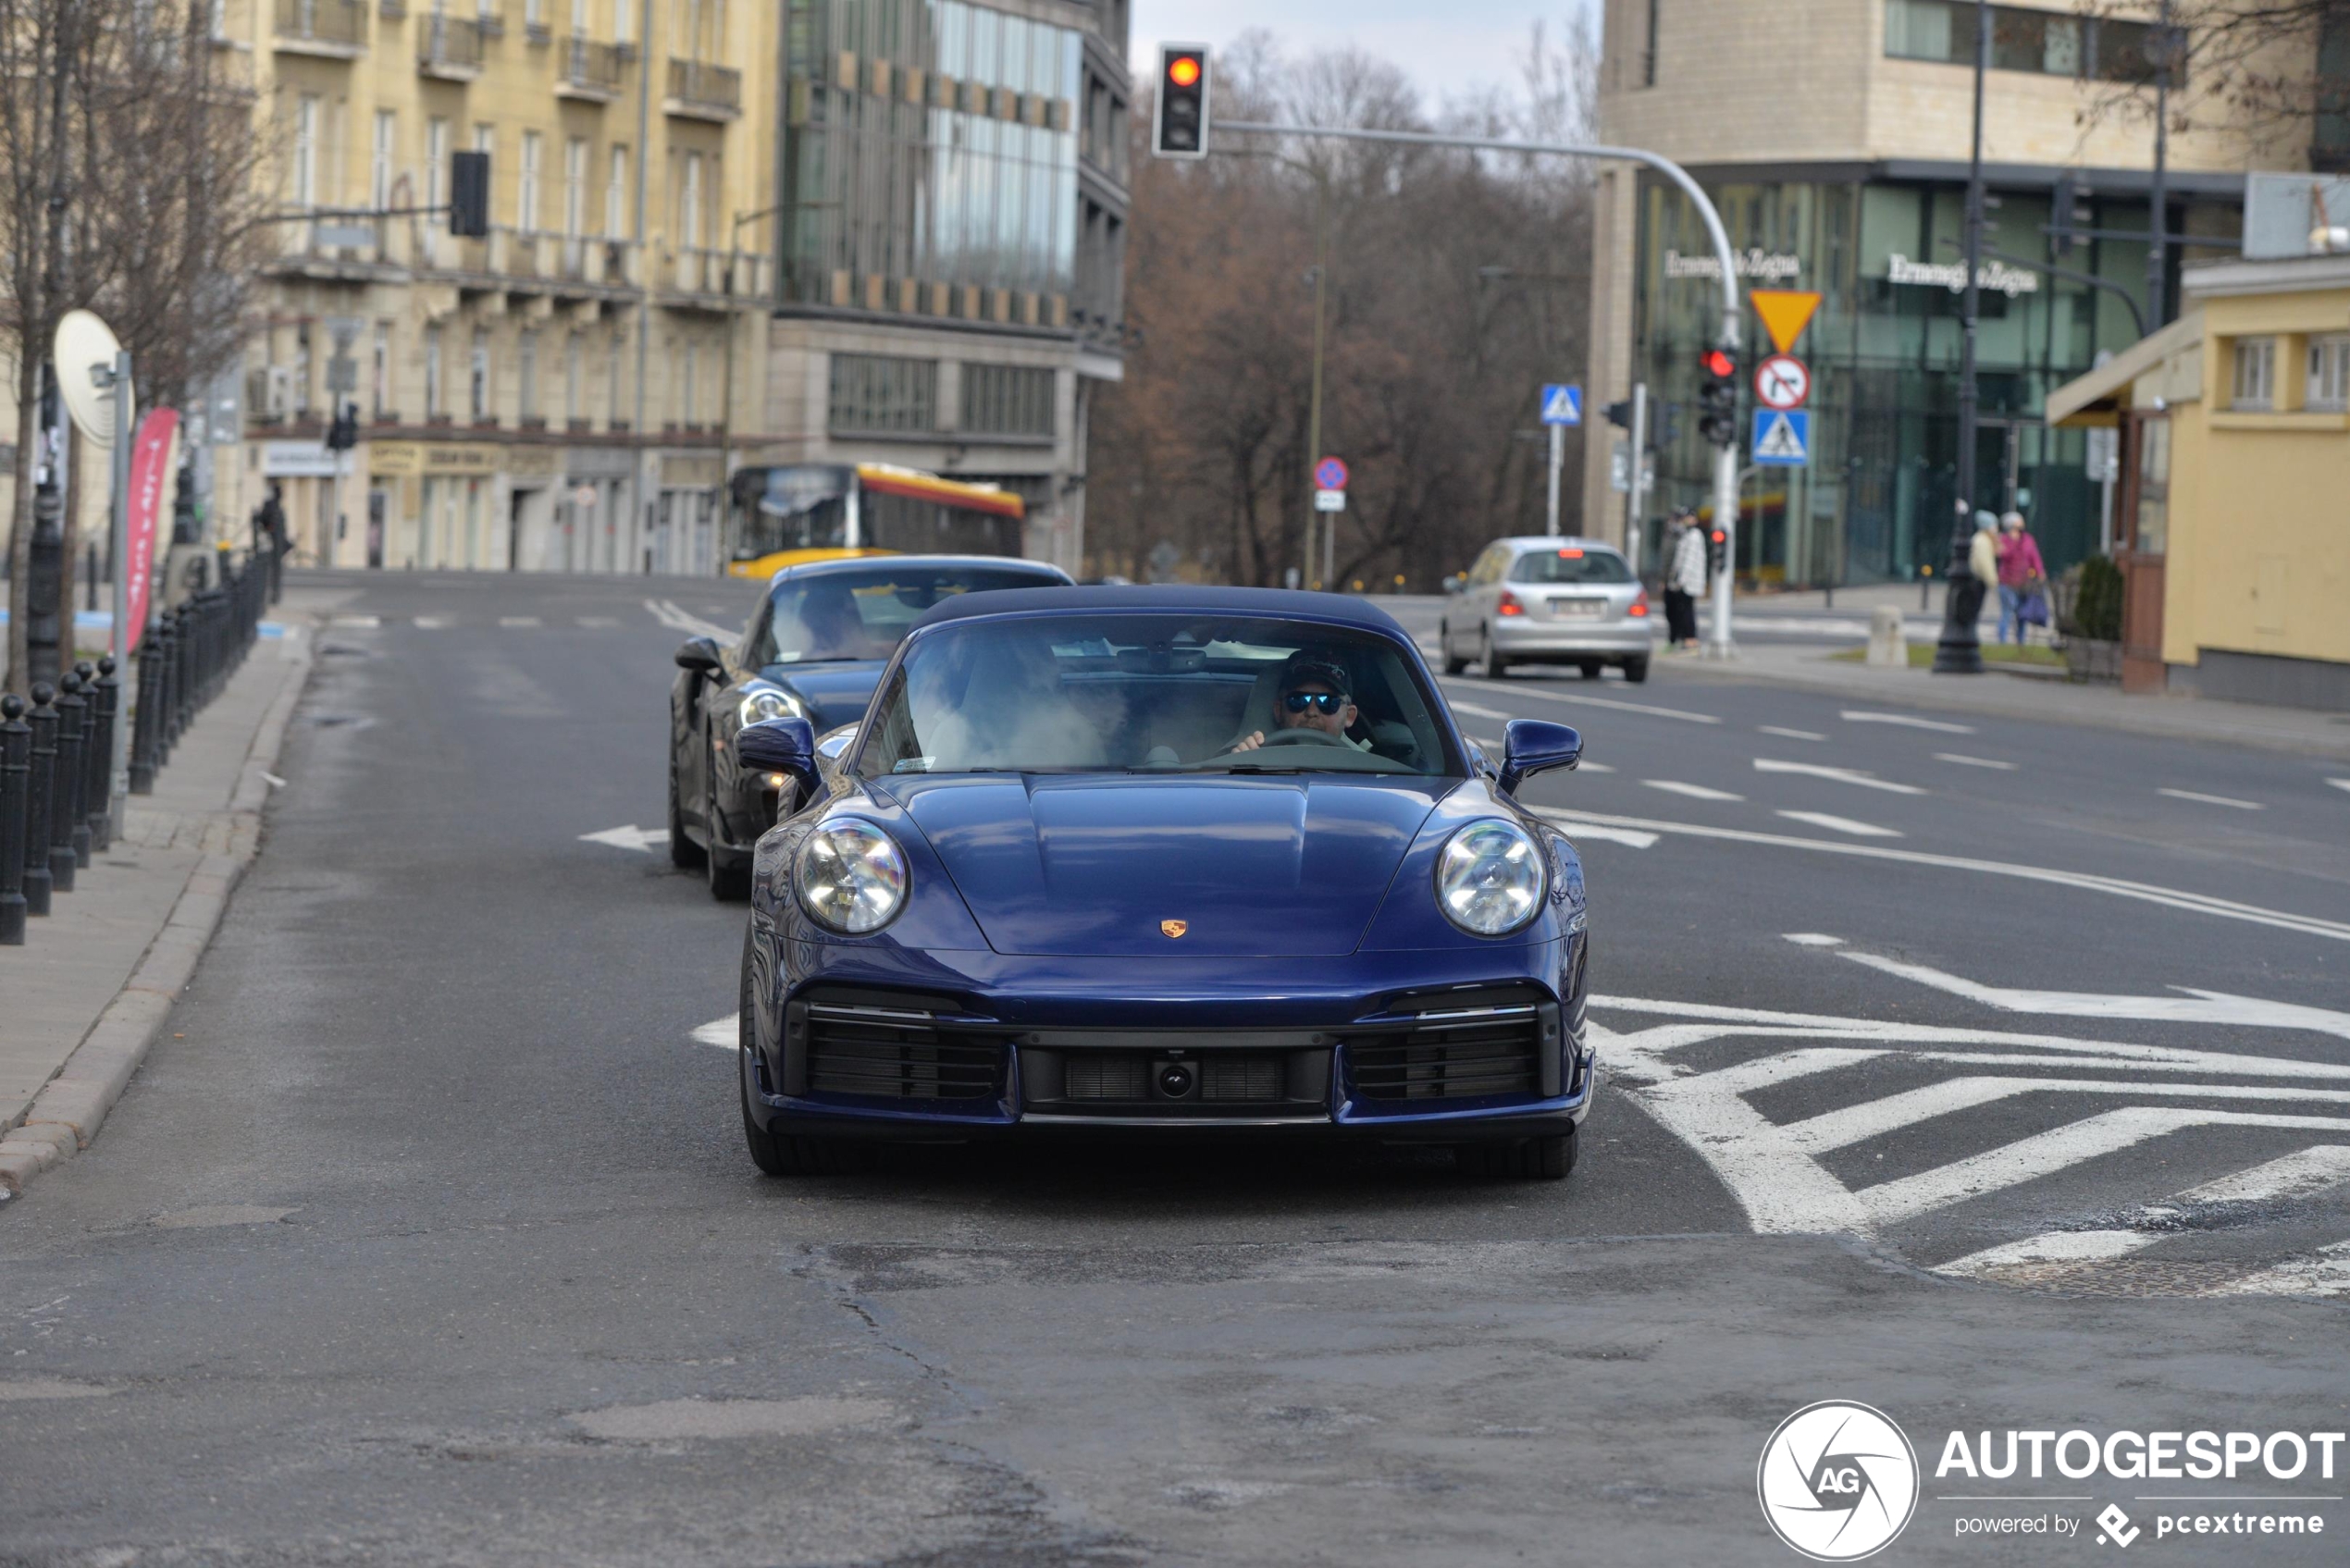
[[876, 776, 1454, 957]]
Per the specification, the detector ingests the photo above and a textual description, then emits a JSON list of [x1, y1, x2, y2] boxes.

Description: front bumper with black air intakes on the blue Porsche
[[743, 933, 1596, 1142]]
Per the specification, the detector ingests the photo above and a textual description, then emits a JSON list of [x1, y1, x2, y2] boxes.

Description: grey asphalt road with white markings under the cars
[[0, 576, 2350, 1568]]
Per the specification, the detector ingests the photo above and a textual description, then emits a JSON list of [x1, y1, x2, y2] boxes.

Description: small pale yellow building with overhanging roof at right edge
[[2047, 237, 2350, 710]]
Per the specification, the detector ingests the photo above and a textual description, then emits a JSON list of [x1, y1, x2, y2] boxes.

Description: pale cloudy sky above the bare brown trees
[[1132, 0, 1596, 108]]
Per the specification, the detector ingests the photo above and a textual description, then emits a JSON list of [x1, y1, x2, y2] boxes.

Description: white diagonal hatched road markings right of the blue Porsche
[[1591, 949, 2350, 1298]]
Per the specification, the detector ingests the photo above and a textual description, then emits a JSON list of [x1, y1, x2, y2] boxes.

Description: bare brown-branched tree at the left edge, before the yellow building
[[0, 0, 268, 684]]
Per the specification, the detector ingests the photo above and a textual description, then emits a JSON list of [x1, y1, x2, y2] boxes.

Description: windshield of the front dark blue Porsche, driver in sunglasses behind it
[[858, 613, 1459, 778]]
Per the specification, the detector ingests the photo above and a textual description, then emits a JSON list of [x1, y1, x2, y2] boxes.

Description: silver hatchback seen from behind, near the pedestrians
[[1436, 534, 1654, 682]]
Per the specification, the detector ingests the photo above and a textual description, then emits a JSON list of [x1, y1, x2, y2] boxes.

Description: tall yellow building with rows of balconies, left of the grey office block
[[216, 0, 778, 572]]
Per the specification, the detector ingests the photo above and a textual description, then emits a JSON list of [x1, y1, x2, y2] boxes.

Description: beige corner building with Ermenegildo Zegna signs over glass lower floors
[[1584, 0, 2321, 583]]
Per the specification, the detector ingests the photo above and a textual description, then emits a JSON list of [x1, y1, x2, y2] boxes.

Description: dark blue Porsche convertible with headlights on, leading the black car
[[736, 586, 1593, 1178]]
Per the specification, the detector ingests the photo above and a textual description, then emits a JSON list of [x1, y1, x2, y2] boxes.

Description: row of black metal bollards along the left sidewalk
[[0, 555, 270, 947]]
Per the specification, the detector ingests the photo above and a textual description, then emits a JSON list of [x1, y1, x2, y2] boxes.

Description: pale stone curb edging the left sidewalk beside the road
[[0, 637, 313, 1196]]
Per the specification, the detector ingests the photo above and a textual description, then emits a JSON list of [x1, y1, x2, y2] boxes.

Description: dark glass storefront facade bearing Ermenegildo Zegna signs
[[1633, 165, 2240, 586]]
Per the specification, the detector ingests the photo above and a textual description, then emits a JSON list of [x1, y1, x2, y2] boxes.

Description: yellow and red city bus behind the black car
[[726, 463, 1027, 581]]
